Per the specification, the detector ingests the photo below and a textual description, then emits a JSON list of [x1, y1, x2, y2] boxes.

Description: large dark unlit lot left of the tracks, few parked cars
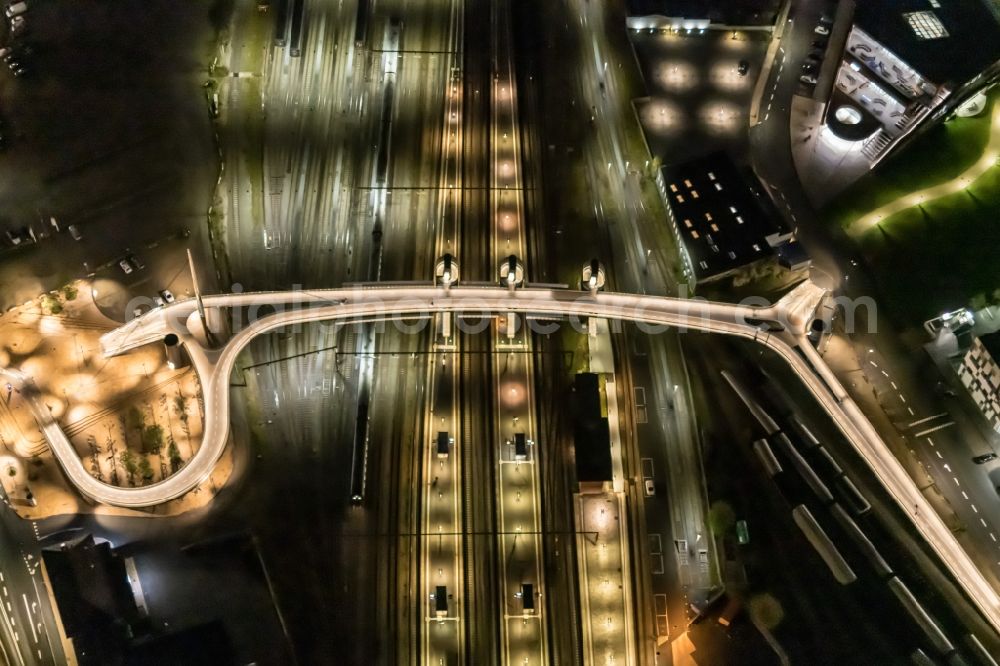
[[0, 0, 218, 318]]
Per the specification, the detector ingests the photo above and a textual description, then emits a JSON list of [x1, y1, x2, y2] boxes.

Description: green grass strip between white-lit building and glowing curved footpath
[[825, 89, 1000, 228]]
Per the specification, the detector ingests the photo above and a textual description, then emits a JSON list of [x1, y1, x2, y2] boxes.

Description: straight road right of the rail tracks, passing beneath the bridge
[[540, 0, 717, 659]]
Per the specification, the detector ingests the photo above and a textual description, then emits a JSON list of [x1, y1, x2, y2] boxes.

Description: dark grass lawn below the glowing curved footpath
[[860, 166, 1000, 325]]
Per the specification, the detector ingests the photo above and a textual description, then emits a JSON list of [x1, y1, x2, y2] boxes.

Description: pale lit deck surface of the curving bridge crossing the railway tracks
[[90, 286, 996, 632]]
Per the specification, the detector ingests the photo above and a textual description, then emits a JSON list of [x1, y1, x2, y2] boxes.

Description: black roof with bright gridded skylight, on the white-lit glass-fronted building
[[854, 0, 1000, 85]]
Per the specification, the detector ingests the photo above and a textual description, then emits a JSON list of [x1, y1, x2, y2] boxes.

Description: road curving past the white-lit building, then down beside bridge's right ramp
[[750, 0, 1000, 600]]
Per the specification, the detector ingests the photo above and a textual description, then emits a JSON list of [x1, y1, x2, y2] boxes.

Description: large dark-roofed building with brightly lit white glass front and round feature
[[814, 0, 1000, 164]]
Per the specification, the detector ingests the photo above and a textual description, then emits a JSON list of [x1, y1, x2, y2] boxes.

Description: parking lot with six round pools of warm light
[[631, 30, 767, 164]]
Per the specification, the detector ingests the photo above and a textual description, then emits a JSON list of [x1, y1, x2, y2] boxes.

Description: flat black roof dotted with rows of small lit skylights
[[663, 152, 789, 281]]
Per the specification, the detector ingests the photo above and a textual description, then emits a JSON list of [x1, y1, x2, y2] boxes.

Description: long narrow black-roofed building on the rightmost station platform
[[573, 372, 612, 493]]
